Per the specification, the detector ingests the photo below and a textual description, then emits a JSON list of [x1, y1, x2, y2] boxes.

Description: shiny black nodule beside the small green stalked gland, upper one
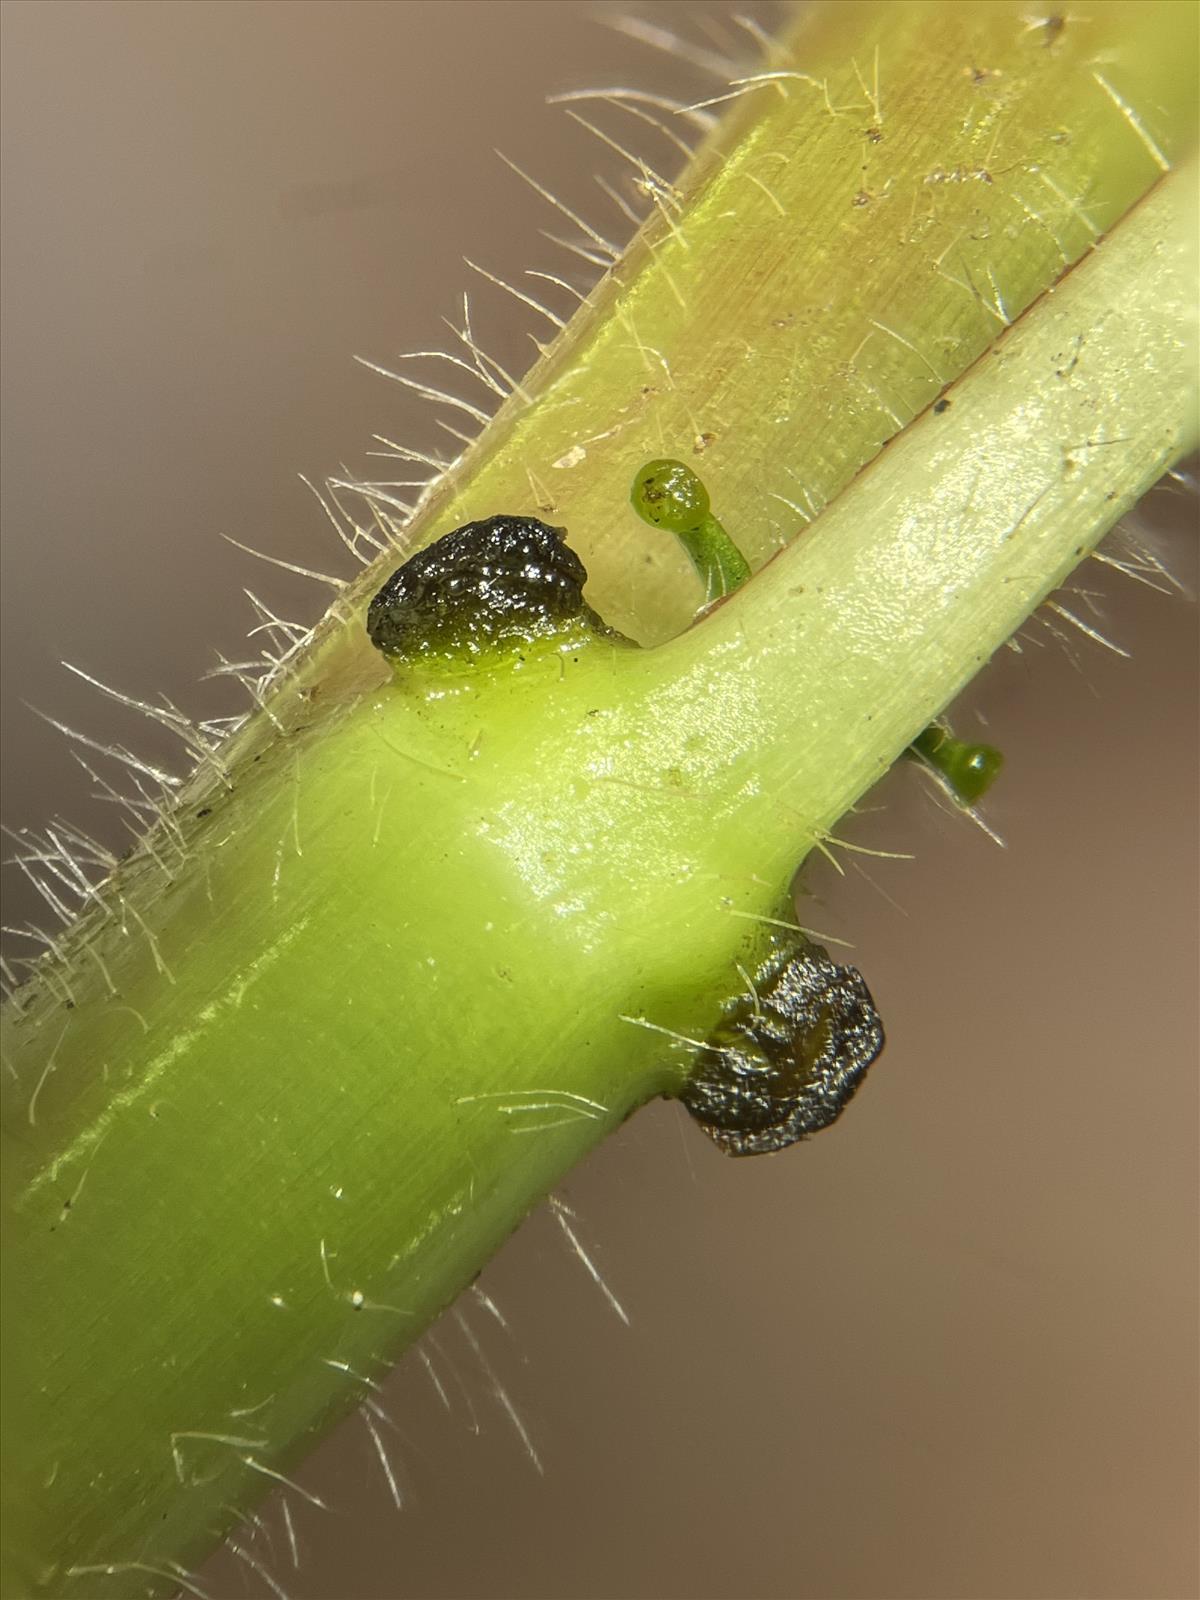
[[366, 517, 619, 662]]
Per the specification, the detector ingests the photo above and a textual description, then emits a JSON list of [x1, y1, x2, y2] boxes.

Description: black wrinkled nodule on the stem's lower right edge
[[680, 939, 883, 1155]]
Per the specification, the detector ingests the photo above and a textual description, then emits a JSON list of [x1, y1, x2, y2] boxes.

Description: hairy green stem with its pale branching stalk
[[5, 5, 1197, 1597]]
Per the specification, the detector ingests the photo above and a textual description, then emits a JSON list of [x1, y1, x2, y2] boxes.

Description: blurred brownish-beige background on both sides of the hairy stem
[[3, 0, 1200, 1600]]
